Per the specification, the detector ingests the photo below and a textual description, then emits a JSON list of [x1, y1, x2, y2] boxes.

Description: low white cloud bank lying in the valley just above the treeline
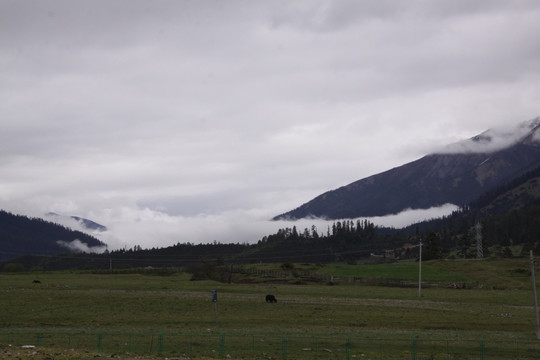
[[79, 204, 458, 249]]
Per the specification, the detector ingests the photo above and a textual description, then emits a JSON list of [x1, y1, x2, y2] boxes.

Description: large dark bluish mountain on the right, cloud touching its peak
[[273, 117, 540, 220]]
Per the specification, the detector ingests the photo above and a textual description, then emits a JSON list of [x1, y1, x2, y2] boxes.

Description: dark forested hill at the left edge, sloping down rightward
[[0, 210, 106, 260]]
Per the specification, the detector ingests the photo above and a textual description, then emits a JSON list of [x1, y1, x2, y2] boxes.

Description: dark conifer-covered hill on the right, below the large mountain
[[243, 167, 540, 262]]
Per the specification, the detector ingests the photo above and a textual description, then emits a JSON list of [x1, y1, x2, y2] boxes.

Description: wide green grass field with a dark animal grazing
[[0, 258, 540, 359]]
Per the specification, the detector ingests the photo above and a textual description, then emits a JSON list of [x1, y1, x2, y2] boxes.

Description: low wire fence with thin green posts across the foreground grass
[[0, 328, 540, 360]]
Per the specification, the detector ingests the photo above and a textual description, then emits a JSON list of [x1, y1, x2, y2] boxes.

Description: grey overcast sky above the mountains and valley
[[0, 0, 540, 248]]
